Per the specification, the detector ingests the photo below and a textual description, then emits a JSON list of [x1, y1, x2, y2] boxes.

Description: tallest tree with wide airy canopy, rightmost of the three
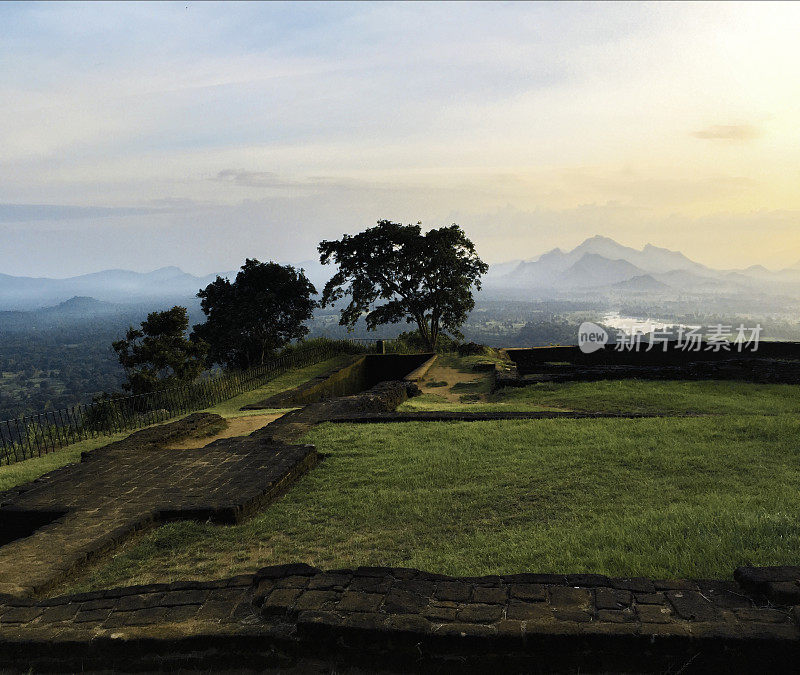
[[318, 220, 489, 350]]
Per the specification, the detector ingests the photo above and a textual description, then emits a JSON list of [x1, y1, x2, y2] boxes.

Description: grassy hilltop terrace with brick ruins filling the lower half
[[0, 353, 800, 672]]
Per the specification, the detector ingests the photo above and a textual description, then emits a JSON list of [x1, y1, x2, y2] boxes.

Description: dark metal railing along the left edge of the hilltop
[[0, 340, 359, 465]]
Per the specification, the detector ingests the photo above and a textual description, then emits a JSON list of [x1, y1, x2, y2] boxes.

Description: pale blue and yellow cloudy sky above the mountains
[[0, 1, 800, 277]]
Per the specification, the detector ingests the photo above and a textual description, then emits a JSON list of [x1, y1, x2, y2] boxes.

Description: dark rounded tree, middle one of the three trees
[[193, 258, 317, 368]]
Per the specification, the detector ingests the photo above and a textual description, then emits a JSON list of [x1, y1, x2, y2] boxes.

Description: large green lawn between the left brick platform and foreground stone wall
[[62, 415, 800, 589]]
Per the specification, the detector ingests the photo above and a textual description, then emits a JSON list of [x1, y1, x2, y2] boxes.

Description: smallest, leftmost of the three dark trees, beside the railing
[[111, 305, 206, 394]]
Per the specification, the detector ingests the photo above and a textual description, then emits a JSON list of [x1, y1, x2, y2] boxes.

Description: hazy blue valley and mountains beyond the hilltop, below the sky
[[0, 236, 800, 419]]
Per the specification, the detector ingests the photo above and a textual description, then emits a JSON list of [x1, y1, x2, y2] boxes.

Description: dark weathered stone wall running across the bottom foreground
[[0, 564, 800, 673]]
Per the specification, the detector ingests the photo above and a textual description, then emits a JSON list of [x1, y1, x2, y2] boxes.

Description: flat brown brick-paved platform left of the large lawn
[[0, 413, 317, 595]]
